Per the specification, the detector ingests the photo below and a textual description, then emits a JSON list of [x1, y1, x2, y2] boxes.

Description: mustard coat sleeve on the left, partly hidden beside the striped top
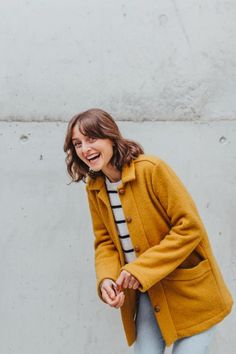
[[87, 189, 121, 297]]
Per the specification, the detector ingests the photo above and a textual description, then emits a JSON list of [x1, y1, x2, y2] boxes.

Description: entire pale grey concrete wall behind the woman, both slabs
[[0, 0, 236, 354]]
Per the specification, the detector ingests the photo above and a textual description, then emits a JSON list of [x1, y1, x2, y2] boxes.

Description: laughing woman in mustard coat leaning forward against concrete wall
[[64, 109, 233, 354]]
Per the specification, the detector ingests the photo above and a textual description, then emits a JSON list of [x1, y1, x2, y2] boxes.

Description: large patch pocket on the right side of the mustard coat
[[161, 259, 224, 330]]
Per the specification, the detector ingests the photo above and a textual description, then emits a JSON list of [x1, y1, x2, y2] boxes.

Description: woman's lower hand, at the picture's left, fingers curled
[[100, 279, 125, 309]]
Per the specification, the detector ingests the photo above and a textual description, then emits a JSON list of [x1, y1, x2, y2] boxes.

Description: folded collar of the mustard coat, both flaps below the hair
[[87, 161, 136, 190]]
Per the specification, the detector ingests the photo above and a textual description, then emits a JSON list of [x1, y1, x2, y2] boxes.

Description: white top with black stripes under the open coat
[[106, 178, 136, 263]]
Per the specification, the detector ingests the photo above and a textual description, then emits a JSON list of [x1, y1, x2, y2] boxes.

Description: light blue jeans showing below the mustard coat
[[134, 293, 216, 354]]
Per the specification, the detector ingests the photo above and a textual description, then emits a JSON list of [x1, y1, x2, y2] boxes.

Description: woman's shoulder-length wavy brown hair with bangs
[[64, 108, 143, 182]]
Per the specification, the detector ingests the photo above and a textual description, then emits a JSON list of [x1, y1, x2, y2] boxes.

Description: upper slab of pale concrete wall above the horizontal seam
[[0, 0, 236, 121]]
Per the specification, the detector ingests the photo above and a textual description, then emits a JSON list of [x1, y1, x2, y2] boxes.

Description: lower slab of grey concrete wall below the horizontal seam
[[0, 122, 236, 354]]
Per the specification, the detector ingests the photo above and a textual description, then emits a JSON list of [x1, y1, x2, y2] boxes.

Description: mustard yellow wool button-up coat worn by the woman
[[87, 155, 233, 346]]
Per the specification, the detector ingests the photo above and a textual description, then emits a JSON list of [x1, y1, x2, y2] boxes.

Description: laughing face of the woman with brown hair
[[72, 124, 114, 175]]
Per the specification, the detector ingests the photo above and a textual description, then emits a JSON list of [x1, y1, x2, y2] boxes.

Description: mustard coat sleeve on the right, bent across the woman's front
[[122, 161, 206, 292]]
